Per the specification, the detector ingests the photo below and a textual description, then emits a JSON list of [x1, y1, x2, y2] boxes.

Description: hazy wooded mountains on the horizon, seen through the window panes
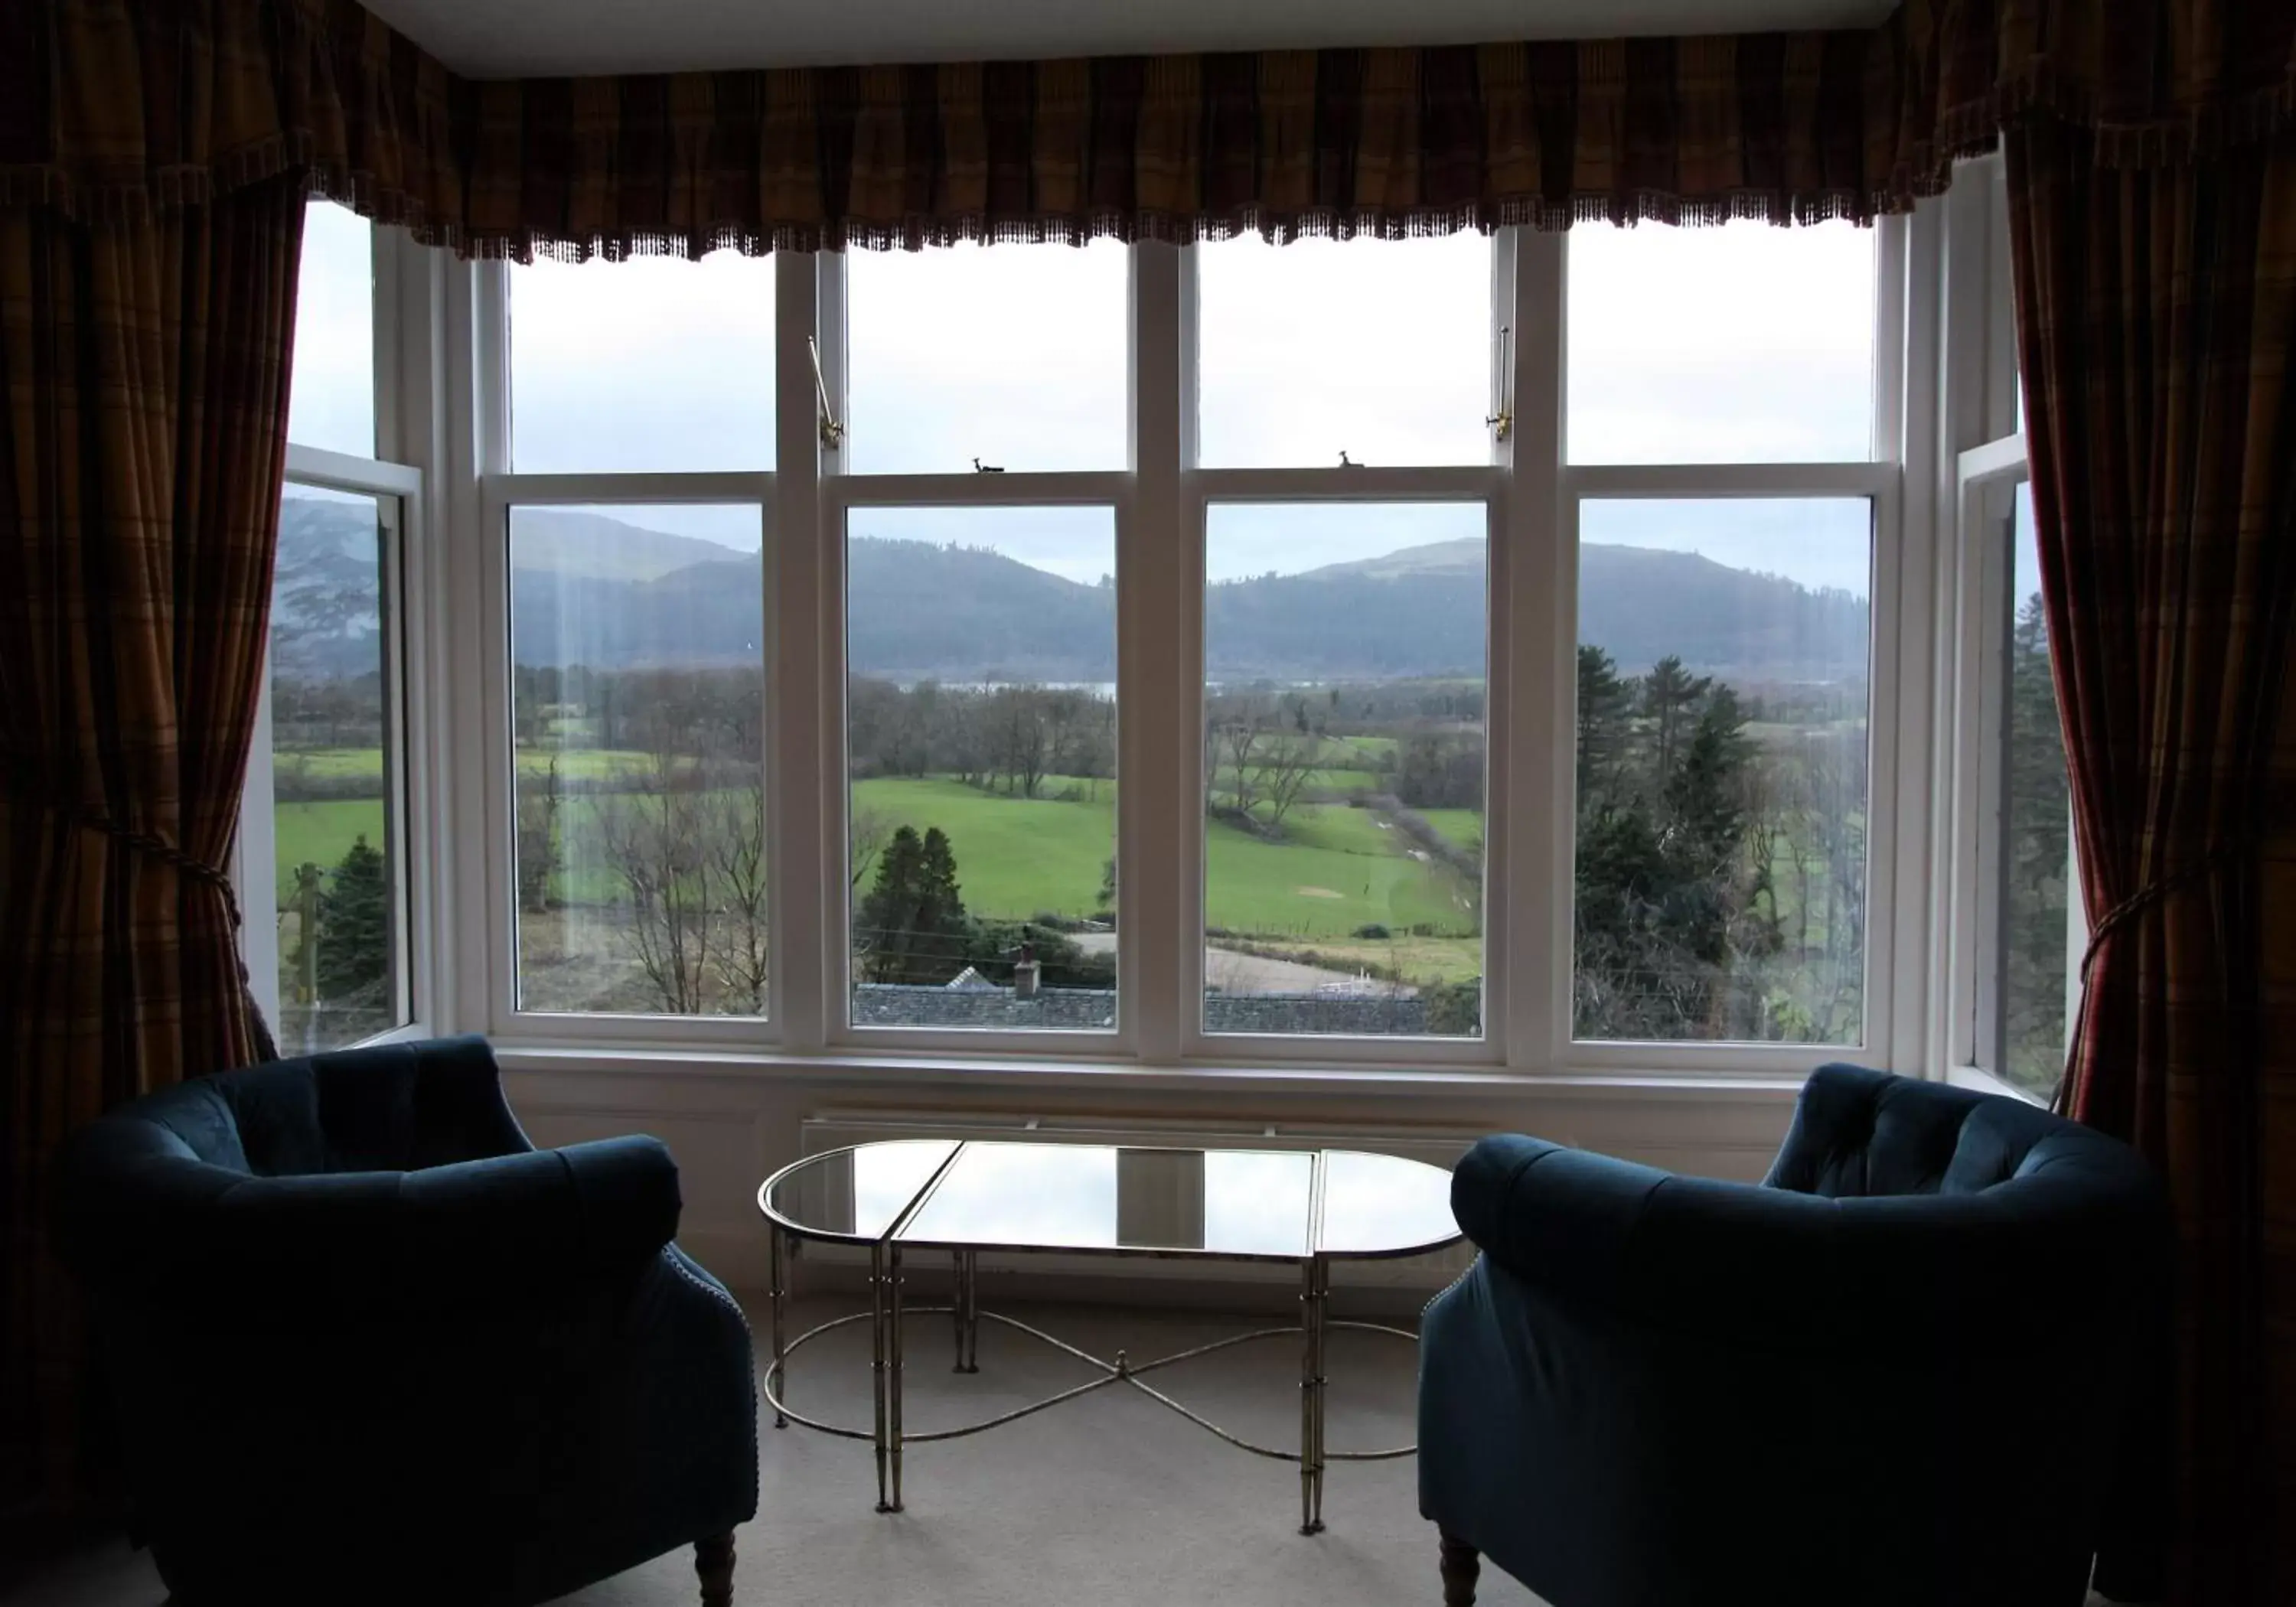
[[276, 498, 1867, 682]]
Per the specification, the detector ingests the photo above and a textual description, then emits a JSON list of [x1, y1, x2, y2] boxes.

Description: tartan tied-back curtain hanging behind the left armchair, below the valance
[[0, 174, 303, 1520]]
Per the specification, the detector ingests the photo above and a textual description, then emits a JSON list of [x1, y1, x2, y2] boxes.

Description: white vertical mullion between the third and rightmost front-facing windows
[[1486, 230, 1577, 1070]]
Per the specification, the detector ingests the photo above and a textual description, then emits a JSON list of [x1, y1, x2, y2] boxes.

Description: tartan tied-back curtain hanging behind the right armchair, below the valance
[[2004, 117, 2296, 1607]]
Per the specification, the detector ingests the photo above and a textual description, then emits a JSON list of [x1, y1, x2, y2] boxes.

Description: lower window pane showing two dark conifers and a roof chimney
[[845, 507, 1116, 1031]]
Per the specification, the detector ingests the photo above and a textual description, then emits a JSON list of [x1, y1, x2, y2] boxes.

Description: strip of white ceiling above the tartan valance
[[367, 0, 1892, 78]]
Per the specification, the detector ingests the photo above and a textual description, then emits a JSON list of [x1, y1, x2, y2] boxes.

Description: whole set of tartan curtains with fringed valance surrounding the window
[[0, 0, 2296, 1607]]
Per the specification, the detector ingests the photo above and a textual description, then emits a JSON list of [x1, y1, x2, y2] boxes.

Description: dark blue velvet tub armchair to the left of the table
[[64, 1038, 758, 1607]]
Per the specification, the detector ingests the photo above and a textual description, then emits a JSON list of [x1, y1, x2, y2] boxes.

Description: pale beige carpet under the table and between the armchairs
[[9, 1279, 1536, 1607]]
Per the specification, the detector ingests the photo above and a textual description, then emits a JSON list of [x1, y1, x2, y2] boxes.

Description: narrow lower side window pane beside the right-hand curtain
[[2000, 484, 2078, 1095]]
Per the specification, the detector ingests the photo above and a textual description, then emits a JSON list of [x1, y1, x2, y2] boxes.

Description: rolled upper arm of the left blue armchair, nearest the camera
[[73, 1136, 680, 1311]]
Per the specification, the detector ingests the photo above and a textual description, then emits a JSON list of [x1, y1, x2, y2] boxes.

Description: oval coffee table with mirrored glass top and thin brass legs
[[758, 1139, 1460, 1534]]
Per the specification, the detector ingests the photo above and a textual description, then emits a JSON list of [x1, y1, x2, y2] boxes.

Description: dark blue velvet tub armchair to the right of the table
[[1419, 1065, 2170, 1607]]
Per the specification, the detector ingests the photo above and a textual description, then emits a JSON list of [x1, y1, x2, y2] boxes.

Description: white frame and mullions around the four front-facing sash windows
[[390, 197, 1993, 1081]]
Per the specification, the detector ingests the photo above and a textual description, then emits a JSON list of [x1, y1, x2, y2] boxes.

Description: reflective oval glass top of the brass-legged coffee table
[[758, 1139, 1460, 1260]]
